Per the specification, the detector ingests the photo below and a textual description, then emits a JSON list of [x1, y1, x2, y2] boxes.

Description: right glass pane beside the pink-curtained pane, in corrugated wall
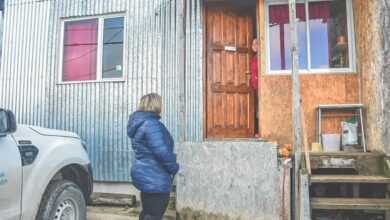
[[102, 17, 124, 78]]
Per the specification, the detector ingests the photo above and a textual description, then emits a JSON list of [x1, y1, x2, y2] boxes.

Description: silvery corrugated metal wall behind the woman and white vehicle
[[0, 0, 203, 181]]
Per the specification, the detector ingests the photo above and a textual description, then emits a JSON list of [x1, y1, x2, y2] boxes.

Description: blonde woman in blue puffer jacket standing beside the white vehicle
[[127, 93, 179, 220]]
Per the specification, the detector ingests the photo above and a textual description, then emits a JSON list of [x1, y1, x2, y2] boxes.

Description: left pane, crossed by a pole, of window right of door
[[269, 4, 308, 70]]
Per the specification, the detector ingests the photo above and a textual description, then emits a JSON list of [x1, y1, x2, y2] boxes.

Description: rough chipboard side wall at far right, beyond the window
[[354, 0, 382, 150]]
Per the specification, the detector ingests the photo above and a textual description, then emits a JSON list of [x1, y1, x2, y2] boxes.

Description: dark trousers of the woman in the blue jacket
[[139, 192, 169, 220]]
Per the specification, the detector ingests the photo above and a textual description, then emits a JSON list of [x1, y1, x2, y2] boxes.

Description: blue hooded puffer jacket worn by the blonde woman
[[127, 111, 179, 193]]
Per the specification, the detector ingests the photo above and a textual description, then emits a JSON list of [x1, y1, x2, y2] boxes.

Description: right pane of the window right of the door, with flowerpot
[[309, 0, 349, 69]]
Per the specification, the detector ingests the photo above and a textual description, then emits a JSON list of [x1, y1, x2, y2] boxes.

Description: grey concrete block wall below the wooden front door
[[177, 140, 290, 220]]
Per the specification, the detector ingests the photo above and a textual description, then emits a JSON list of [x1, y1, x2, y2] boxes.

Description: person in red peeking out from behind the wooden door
[[251, 38, 260, 138]]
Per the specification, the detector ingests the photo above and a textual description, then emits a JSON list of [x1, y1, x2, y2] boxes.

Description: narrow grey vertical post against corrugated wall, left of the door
[[176, 0, 186, 143]]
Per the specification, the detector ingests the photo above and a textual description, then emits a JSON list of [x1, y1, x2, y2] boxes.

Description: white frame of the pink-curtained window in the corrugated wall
[[57, 13, 127, 84]]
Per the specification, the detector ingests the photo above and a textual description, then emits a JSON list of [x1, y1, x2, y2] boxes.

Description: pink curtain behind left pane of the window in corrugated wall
[[63, 19, 98, 81]]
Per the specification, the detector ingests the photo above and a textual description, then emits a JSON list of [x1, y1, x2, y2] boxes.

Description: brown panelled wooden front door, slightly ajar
[[206, 3, 254, 138]]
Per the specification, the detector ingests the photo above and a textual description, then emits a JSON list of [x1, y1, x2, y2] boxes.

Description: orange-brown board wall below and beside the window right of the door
[[259, 1, 359, 148]]
